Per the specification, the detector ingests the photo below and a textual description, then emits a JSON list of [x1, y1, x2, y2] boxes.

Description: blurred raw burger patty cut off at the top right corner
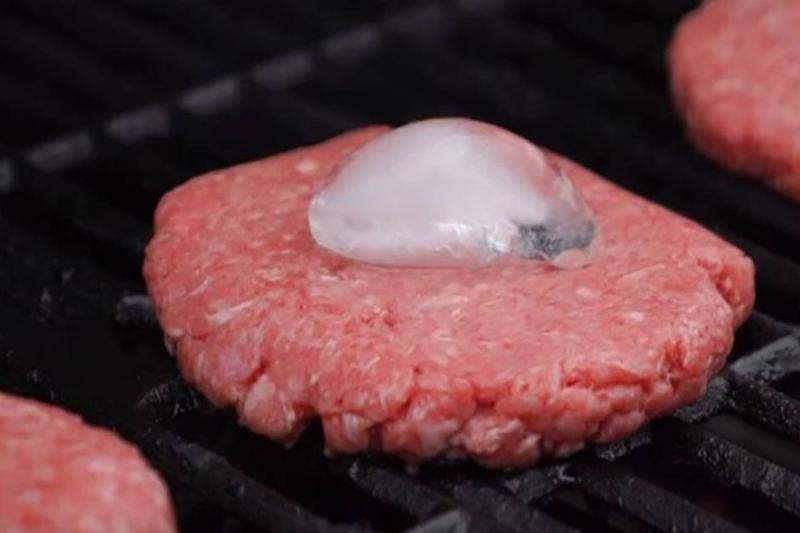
[[669, 0, 800, 202]]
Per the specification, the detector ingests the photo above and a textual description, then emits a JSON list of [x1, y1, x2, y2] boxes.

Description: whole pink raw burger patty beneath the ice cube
[[144, 127, 754, 467]]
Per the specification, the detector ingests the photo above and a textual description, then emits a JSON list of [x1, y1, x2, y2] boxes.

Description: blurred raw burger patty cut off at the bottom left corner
[[0, 393, 175, 533]]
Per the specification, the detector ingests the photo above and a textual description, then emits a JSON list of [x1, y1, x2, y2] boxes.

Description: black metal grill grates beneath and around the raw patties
[[0, 0, 800, 532]]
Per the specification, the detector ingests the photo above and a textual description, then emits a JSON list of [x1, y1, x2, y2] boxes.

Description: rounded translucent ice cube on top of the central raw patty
[[308, 118, 599, 268]]
